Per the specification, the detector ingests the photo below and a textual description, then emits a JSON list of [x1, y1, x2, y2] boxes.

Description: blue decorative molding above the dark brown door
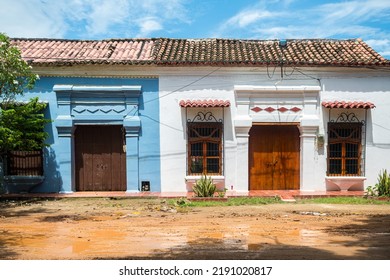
[[53, 85, 142, 133]]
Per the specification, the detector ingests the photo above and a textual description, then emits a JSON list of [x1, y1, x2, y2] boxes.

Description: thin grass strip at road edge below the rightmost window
[[296, 197, 390, 205]]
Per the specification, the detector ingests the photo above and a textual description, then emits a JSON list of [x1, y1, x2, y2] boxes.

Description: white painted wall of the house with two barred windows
[[159, 67, 390, 192]]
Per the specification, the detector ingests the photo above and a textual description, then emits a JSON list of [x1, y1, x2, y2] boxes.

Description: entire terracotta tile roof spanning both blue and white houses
[[13, 38, 390, 67]]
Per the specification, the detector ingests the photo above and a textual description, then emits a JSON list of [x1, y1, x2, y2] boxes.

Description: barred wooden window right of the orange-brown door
[[327, 123, 362, 176]]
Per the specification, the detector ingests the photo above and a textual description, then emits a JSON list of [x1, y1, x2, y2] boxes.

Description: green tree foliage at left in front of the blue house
[[0, 33, 50, 153]]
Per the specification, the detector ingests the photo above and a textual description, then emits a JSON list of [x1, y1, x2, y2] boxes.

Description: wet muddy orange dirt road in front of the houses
[[0, 198, 390, 260]]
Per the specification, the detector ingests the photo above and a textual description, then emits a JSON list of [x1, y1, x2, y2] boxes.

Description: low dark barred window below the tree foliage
[[5, 150, 43, 176]]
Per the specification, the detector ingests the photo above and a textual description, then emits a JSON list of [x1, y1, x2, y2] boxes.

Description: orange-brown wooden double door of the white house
[[249, 125, 300, 190]]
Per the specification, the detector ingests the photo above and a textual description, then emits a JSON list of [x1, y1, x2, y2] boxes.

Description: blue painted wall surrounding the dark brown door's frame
[[20, 77, 161, 192]]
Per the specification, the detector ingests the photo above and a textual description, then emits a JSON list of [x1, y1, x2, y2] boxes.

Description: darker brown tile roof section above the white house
[[155, 39, 390, 66]]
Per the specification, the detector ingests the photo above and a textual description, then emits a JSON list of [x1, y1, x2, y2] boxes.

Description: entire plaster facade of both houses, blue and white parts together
[[9, 66, 390, 192]]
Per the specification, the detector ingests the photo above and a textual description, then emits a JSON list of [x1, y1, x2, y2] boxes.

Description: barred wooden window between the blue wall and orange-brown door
[[187, 122, 222, 175]]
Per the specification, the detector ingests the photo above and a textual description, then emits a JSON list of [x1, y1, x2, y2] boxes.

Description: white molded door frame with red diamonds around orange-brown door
[[233, 85, 325, 193]]
